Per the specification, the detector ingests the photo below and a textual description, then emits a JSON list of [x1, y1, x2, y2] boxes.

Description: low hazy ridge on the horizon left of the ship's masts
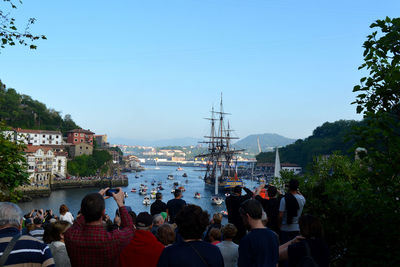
[[109, 137, 202, 147]]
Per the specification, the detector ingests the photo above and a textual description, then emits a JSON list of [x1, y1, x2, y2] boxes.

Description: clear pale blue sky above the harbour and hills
[[0, 0, 400, 140]]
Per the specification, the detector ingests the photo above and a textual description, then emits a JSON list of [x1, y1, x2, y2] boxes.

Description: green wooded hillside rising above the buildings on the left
[[0, 81, 80, 134]]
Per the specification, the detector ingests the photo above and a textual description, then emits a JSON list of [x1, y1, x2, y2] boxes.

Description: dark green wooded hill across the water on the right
[[256, 120, 361, 168]]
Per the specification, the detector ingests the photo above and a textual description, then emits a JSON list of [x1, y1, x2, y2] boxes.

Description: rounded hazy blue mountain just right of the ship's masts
[[233, 133, 296, 154]]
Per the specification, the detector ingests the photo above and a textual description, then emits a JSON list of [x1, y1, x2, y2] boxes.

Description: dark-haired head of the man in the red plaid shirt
[[81, 193, 106, 223]]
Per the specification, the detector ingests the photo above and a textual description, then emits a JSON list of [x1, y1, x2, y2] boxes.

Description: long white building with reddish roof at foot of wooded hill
[[7, 128, 64, 146]]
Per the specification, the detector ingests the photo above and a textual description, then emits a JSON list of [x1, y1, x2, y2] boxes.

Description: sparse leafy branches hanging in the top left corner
[[0, 0, 46, 49]]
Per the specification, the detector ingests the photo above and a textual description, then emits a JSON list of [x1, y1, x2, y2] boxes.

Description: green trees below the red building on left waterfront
[[67, 150, 112, 176]]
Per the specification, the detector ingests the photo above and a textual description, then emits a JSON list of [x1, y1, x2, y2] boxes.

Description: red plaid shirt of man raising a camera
[[65, 207, 134, 267]]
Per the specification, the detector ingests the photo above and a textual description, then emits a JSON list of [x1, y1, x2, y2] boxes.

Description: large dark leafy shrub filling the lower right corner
[[299, 154, 400, 266]]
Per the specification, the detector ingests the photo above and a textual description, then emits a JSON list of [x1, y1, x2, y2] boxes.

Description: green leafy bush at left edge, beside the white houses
[[0, 123, 28, 201]]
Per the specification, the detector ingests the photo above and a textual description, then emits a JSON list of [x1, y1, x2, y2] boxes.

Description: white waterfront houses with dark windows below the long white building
[[25, 146, 67, 187]]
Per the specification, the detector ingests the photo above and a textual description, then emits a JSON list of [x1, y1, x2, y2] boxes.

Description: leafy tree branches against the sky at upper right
[[353, 17, 400, 116]]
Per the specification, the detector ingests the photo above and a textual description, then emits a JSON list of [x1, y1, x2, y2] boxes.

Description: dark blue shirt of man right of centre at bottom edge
[[238, 228, 279, 267]]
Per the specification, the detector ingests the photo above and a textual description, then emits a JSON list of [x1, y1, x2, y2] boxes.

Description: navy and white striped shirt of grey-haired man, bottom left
[[0, 227, 55, 267]]
